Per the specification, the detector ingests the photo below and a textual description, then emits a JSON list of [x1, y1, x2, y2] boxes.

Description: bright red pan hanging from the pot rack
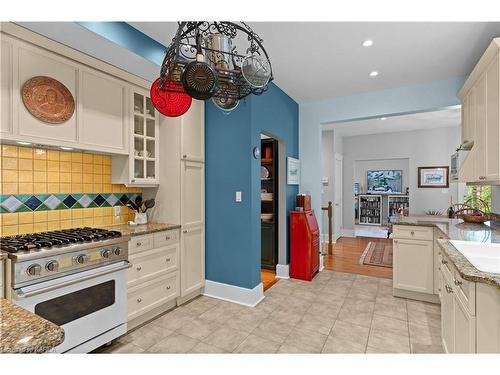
[[150, 78, 193, 117]]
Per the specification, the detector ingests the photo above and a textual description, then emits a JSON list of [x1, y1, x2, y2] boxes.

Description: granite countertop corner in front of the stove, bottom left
[[0, 298, 64, 353]]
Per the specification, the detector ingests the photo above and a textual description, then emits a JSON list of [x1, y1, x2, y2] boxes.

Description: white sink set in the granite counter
[[450, 240, 500, 273]]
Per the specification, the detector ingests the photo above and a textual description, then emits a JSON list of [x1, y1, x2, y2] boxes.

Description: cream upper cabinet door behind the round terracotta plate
[[13, 44, 78, 145]]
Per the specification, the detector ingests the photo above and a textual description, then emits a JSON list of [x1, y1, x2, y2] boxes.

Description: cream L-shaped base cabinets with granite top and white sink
[[393, 216, 500, 353]]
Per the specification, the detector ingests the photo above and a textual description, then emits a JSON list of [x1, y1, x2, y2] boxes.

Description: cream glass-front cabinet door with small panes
[[130, 89, 159, 185]]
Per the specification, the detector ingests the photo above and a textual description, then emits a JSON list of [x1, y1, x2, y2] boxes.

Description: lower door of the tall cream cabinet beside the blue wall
[[181, 225, 205, 297]]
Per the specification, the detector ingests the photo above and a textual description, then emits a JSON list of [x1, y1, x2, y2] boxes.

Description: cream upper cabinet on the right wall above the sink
[[458, 38, 500, 185]]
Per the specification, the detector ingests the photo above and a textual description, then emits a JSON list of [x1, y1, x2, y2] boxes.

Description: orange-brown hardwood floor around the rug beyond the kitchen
[[324, 237, 392, 279]]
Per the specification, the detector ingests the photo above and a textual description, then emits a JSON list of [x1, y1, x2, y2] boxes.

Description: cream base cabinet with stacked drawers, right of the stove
[[127, 229, 182, 329]]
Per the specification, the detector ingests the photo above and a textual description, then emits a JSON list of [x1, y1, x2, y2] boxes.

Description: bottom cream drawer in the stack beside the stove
[[128, 271, 179, 321]]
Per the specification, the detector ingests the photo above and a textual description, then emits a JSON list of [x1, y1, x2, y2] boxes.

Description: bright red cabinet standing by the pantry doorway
[[290, 210, 319, 281]]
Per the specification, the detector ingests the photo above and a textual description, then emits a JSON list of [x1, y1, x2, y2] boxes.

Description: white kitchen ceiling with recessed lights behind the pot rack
[[129, 22, 500, 102]]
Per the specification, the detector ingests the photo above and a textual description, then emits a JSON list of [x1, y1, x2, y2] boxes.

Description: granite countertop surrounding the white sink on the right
[[392, 216, 500, 288]]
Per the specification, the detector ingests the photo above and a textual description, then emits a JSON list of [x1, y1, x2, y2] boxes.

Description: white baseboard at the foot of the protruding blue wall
[[203, 280, 264, 307]]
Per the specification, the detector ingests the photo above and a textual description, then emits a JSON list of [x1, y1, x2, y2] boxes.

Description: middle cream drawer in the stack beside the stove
[[127, 245, 179, 287]]
